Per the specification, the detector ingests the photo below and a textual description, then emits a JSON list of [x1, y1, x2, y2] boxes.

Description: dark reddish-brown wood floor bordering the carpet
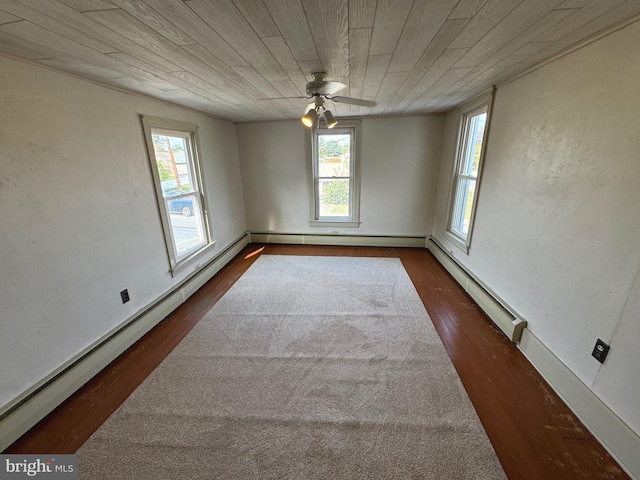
[[5, 244, 629, 480]]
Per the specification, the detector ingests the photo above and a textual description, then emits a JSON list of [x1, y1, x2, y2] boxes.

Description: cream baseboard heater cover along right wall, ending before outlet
[[427, 238, 527, 343]]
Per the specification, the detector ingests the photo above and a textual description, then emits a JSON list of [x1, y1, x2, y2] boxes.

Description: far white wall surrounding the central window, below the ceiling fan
[[236, 116, 443, 236]]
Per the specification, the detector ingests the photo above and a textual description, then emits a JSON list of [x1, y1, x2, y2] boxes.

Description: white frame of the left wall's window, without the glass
[[140, 115, 215, 276]]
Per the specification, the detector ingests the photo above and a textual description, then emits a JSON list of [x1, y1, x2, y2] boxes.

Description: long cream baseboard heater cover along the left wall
[[0, 233, 251, 451]]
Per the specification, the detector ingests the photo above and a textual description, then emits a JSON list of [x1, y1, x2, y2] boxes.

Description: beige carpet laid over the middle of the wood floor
[[78, 255, 505, 480]]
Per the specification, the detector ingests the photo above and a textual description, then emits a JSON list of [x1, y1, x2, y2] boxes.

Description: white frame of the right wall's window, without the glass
[[446, 93, 493, 254]]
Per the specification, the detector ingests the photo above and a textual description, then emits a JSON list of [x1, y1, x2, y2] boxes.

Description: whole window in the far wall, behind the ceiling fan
[[311, 122, 360, 227]]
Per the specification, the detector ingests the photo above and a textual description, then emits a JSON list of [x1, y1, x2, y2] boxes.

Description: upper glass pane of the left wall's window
[[151, 133, 195, 197]]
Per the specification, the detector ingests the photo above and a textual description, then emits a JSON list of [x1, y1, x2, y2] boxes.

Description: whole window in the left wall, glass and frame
[[142, 116, 212, 273]]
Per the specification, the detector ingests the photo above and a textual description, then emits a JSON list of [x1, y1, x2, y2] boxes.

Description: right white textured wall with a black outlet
[[433, 23, 640, 433]]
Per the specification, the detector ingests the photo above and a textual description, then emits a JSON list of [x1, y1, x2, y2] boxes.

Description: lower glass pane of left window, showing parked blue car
[[165, 195, 206, 257]]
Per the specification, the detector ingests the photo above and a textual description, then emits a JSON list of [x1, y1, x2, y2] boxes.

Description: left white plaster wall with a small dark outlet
[[0, 57, 246, 407]]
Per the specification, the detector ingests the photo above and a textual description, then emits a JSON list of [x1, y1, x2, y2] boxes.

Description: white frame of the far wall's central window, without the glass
[[309, 120, 360, 228]]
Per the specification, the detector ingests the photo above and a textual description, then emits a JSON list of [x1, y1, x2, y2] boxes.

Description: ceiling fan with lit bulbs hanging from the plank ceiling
[[264, 72, 376, 128]]
